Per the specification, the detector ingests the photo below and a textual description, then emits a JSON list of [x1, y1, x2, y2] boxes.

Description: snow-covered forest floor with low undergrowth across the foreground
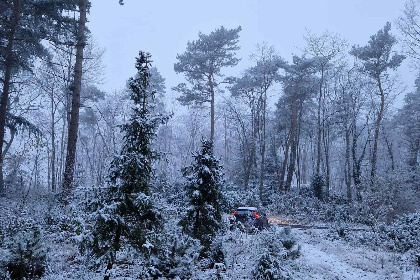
[[0, 190, 420, 280]]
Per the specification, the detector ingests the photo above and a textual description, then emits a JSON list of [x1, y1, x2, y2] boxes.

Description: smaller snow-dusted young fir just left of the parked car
[[180, 140, 226, 253]]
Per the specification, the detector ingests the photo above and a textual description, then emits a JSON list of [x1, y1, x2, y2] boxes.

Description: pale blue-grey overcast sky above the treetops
[[88, 0, 414, 106]]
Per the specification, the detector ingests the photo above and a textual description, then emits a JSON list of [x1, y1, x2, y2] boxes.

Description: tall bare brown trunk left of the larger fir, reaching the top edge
[[63, 0, 87, 198]]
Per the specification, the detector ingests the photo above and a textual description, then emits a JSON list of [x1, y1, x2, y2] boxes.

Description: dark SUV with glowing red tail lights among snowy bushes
[[232, 207, 268, 230]]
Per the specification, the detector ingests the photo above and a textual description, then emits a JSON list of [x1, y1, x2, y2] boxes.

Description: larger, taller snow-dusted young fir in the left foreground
[[87, 52, 167, 279]]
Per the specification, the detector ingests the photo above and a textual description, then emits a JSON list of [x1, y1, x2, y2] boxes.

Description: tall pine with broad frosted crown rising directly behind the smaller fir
[[173, 26, 241, 144]]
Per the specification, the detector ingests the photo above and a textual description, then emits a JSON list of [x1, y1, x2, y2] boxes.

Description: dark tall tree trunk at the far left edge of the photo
[[0, 0, 20, 195]]
